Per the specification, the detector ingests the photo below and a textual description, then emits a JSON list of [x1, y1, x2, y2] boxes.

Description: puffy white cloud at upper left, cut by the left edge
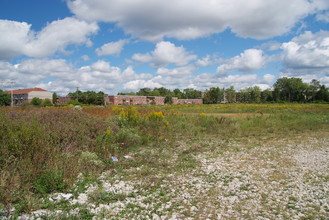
[[0, 17, 98, 59]]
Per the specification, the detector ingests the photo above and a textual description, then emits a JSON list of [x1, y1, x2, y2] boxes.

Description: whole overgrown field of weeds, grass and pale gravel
[[0, 104, 329, 219]]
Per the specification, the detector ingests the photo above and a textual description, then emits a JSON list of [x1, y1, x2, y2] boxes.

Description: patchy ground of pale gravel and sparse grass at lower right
[[20, 133, 329, 219]]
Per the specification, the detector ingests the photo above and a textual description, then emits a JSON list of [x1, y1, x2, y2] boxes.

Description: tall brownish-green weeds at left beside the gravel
[[0, 108, 112, 211]]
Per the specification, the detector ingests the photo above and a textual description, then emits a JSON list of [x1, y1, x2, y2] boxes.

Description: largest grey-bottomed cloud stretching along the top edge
[[68, 0, 328, 41]]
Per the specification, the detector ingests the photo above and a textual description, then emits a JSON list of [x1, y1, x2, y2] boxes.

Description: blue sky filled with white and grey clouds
[[0, 0, 329, 95]]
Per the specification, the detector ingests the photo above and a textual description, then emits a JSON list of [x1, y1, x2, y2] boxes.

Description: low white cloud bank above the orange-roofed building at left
[[0, 59, 146, 95]]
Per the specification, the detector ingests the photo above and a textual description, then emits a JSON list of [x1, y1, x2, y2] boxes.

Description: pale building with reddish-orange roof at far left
[[5, 88, 53, 105]]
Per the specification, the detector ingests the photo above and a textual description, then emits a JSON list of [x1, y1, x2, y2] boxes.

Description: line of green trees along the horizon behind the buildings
[[0, 77, 329, 106]]
